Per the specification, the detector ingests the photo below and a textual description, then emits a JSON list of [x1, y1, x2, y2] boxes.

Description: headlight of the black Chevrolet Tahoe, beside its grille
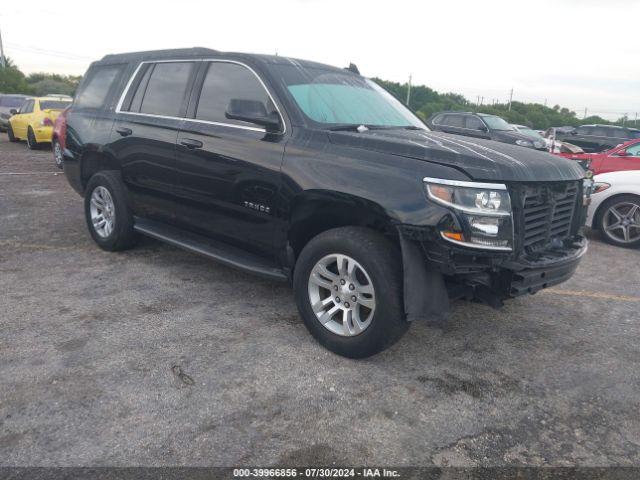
[[424, 177, 513, 251]]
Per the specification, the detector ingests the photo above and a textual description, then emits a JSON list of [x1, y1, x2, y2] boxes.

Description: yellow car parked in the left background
[[7, 96, 71, 150]]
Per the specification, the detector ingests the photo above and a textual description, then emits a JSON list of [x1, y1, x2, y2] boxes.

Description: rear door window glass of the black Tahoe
[[134, 62, 194, 117]]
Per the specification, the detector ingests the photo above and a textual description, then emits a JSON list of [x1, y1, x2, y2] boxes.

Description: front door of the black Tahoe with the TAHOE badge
[[176, 60, 284, 256]]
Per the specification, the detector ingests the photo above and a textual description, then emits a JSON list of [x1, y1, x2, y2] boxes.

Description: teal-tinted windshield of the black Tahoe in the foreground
[[277, 65, 427, 130]]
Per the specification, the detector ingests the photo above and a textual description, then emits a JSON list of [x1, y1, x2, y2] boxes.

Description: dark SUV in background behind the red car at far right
[[555, 125, 640, 153]]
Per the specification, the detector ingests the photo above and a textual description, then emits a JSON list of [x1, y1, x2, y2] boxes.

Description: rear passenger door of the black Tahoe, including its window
[[110, 60, 199, 223]]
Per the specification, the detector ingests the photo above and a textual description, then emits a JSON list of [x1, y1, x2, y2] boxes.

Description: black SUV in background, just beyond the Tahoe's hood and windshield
[[427, 112, 547, 150]]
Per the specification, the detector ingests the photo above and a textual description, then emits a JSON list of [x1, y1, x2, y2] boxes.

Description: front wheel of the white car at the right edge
[[596, 195, 640, 248]]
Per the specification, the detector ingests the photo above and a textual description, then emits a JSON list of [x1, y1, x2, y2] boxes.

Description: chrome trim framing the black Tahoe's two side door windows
[[115, 58, 287, 135]]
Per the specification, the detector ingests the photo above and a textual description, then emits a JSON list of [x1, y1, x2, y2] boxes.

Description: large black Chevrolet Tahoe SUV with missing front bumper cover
[[64, 49, 587, 357]]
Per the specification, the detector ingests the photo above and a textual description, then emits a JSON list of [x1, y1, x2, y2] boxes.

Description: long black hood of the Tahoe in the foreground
[[329, 129, 584, 182]]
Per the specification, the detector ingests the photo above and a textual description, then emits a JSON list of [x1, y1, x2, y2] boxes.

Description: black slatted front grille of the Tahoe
[[516, 182, 580, 252]]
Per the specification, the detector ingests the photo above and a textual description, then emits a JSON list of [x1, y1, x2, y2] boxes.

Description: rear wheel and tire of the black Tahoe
[[84, 170, 136, 251]]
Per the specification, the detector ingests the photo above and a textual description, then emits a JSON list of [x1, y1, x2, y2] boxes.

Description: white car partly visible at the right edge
[[587, 170, 640, 247]]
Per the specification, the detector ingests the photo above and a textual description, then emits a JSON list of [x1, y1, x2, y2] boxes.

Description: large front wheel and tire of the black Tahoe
[[293, 227, 410, 358]]
